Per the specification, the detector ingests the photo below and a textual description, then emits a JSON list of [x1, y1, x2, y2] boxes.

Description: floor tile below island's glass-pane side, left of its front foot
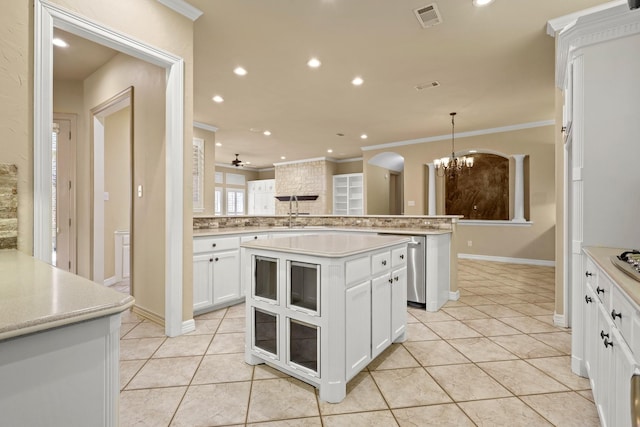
[[247, 378, 320, 422]]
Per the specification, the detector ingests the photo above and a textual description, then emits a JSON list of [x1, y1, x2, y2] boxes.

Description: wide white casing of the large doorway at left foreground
[[33, 0, 185, 336]]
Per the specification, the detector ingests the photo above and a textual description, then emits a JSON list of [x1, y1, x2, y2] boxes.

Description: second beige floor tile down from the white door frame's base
[[125, 356, 201, 390]]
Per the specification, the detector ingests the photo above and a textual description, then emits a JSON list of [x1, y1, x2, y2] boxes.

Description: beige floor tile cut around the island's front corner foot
[[316, 371, 388, 415]]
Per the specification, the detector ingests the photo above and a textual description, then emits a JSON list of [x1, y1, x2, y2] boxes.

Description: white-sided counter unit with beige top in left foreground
[[0, 250, 134, 426]]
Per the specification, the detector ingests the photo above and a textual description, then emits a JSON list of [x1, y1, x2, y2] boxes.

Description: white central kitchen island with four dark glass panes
[[241, 234, 409, 403]]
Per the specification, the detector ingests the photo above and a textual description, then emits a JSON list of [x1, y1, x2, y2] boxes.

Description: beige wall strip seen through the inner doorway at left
[[104, 107, 131, 280]]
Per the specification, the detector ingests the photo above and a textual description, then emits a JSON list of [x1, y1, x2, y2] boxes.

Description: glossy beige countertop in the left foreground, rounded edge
[[0, 250, 134, 341]]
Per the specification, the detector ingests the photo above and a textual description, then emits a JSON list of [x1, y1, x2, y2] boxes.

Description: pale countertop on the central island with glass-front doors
[[240, 233, 409, 258]]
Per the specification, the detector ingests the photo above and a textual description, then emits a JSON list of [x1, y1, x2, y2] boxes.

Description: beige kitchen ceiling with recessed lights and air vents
[[54, 0, 607, 171]]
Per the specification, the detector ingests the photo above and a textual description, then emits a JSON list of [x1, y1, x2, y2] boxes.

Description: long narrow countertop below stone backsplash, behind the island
[[193, 225, 451, 237]]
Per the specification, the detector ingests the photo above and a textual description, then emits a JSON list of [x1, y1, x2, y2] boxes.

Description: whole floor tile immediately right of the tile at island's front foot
[[371, 368, 451, 408]]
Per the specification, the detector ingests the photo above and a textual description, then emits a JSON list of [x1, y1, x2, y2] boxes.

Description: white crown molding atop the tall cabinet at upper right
[[556, 1, 640, 89]]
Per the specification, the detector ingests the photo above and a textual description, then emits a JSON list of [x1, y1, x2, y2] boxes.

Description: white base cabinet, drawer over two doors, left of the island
[[193, 236, 243, 313]]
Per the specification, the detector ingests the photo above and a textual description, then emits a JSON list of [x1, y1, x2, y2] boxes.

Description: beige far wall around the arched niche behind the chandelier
[[364, 126, 556, 261]]
